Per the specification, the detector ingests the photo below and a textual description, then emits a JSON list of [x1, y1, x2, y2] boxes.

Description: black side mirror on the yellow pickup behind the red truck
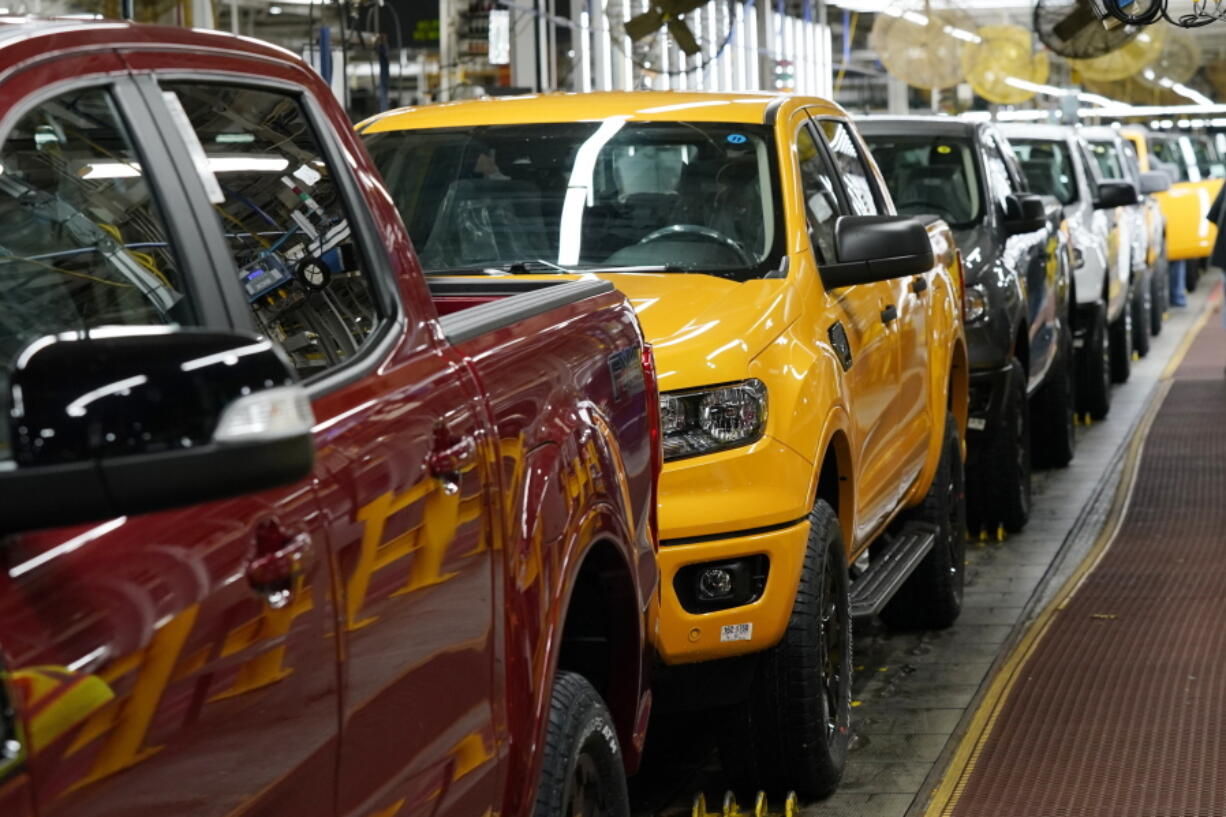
[[821, 216, 937, 290]]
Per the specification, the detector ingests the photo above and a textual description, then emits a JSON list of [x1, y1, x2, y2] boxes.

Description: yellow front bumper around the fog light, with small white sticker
[[652, 520, 809, 664]]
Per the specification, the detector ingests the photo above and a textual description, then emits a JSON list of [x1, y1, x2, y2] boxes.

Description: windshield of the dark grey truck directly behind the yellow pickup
[[864, 134, 983, 229]]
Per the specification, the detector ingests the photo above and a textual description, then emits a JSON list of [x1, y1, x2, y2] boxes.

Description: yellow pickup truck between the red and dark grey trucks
[[359, 93, 967, 797]]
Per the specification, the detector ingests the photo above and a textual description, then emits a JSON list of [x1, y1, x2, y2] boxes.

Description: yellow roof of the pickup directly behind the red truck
[[358, 91, 845, 134]]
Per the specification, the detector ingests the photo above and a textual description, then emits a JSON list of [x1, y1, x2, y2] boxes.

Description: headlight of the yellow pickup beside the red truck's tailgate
[[660, 380, 766, 460]]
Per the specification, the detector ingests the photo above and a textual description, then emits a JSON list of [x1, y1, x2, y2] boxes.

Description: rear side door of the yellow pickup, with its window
[[814, 118, 934, 508]]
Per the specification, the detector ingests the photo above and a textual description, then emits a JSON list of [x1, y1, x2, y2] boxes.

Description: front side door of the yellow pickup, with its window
[[793, 113, 899, 539]]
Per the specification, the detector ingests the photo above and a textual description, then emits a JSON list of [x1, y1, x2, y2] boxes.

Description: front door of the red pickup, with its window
[[0, 65, 340, 817]]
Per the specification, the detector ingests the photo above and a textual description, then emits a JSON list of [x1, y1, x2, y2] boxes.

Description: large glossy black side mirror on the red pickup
[[0, 326, 315, 532]]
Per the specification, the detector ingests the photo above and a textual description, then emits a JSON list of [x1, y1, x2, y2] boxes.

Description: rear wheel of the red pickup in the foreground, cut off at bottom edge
[[532, 671, 630, 817]]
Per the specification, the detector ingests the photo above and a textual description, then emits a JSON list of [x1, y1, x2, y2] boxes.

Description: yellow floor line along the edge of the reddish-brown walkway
[[924, 287, 1222, 817]]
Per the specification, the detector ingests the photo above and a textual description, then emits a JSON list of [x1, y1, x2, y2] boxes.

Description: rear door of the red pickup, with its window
[[128, 65, 498, 817]]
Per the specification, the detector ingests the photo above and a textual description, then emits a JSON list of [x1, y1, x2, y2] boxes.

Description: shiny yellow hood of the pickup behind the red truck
[[600, 272, 799, 391]]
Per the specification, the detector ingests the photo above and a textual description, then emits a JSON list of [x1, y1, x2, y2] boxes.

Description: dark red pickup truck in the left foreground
[[0, 22, 660, 817]]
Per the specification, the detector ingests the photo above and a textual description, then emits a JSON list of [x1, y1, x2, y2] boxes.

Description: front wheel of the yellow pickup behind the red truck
[[720, 499, 851, 800]]
